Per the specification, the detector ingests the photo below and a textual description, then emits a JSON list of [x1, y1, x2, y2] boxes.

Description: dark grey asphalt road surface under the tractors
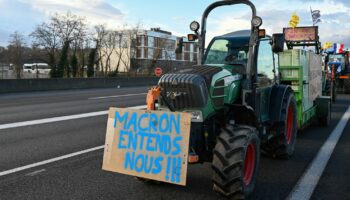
[[0, 87, 350, 200]]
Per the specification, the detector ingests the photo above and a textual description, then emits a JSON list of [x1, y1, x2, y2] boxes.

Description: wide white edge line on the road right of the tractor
[[287, 106, 350, 200]]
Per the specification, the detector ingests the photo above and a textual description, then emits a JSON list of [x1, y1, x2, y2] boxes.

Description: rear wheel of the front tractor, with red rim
[[262, 91, 297, 159]]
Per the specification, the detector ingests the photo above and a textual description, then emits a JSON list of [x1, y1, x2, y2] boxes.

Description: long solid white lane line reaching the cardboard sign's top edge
[[0, 105, 146, 130]]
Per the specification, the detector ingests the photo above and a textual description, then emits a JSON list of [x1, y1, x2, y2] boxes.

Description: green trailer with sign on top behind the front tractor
[[278, 27, 331, 129]]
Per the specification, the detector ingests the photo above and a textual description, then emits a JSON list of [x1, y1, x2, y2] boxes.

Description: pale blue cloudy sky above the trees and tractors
[[0, 0, 350, 48]]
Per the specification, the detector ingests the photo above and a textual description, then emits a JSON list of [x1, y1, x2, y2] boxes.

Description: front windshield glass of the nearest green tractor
[[204, 37, 249, 65]]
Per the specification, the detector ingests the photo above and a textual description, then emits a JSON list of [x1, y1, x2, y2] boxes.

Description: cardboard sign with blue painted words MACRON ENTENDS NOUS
[[102, 108, 191, 185]]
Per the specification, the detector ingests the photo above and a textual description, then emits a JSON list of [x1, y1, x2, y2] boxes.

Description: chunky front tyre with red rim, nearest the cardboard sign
[[212, 125, 260, 199]]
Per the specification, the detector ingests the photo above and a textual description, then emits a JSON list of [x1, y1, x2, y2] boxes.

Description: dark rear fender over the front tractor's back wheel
[[269, 85, 293, 123]]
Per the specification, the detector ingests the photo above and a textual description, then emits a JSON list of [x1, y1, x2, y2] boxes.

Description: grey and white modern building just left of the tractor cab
[[130, 28, 198, 73]]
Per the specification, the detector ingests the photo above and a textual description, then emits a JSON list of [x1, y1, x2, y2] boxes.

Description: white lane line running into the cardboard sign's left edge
[[0, 145, 104, 177]]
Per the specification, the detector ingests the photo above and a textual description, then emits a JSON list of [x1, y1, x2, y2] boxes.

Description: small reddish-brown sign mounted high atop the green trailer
[[283, 26, 317, 42]]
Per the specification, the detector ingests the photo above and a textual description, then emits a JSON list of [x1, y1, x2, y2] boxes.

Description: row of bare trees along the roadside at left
[[0, 12, 139, 78]]
